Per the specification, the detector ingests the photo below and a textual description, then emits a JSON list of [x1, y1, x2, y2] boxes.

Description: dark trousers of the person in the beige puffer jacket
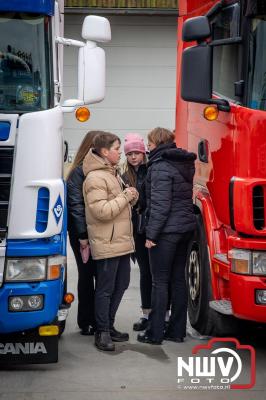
[[95, 254, 130, 332]]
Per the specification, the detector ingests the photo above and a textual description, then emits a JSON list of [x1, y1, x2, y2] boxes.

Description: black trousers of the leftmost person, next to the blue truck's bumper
[[69, 233, 96, 329]]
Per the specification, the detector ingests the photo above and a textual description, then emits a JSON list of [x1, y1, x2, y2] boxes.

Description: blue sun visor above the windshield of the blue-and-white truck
[[0, 0, 54, 15]]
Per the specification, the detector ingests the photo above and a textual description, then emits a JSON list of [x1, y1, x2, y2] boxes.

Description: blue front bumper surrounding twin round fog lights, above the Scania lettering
[[0, 279, 62, 334]]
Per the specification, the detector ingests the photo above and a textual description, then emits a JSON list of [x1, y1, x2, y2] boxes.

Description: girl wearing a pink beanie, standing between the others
[[122, 133, 152, 331]]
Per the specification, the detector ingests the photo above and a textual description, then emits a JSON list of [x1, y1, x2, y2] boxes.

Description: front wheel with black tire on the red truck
[[187, 215, 213, 335]]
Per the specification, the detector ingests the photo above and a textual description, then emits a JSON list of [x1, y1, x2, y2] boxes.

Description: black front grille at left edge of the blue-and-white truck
[[0, 147, 14, 238]]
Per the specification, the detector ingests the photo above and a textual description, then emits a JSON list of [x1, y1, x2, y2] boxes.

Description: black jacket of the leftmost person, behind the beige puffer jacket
[[67, 165, 88, 239]]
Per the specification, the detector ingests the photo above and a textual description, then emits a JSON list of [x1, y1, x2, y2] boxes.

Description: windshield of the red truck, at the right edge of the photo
[[248, 16, 266, 110]]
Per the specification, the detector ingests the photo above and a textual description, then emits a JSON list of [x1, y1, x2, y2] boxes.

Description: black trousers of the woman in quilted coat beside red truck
[[147, 232, 192, 341]]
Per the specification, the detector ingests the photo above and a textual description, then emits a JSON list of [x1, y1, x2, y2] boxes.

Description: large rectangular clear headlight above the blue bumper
[[5, 257, 47, 282]]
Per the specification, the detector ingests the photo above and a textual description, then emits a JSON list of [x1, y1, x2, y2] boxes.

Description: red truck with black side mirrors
[[176, 0, 266, 335]]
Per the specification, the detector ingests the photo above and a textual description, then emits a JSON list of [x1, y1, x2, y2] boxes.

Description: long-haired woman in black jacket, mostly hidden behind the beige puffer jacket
[[67, 131, 99, 335]]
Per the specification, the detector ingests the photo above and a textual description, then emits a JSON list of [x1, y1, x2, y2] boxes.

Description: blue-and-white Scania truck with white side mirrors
[[0, 0, 111, 364]]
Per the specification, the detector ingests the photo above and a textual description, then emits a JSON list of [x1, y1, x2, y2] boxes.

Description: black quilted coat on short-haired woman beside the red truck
[[146, 143, 196, 242]]
